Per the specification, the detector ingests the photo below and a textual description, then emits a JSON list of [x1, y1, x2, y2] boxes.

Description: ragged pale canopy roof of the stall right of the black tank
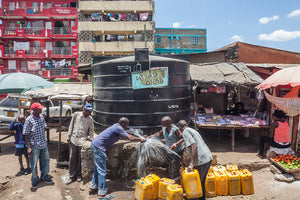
[[191, 62, 263, 85]]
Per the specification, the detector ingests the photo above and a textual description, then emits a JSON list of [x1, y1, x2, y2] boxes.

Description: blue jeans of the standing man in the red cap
[[29, 145, 50, 184]]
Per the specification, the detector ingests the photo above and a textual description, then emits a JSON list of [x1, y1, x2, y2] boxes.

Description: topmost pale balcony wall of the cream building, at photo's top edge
[[79, 0, 154, 13]]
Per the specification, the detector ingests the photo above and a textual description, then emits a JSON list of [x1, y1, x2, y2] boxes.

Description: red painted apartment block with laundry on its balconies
[[0, 0, 78, 79]]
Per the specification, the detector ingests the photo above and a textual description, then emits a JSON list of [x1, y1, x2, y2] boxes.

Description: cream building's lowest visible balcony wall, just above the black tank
[[79, 41, 154, 55]]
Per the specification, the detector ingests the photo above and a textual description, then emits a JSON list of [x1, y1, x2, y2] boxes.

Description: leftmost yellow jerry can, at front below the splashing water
[[134, 178, 153, 200]]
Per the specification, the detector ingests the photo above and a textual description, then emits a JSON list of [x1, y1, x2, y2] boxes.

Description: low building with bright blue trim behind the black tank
[[154, 28, 207, 55]]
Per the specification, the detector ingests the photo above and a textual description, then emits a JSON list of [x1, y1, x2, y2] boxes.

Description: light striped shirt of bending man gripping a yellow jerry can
[[182, 127, 212, 166]]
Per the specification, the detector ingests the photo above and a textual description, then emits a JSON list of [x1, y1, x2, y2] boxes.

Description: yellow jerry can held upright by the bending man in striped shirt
[[182, 169, 203, 199]]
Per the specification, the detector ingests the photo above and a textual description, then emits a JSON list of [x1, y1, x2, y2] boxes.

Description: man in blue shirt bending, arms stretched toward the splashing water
[[90, 117, 144, 199]]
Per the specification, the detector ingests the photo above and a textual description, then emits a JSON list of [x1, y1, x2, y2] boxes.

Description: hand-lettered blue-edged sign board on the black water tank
[[131, 67, 169, 90]]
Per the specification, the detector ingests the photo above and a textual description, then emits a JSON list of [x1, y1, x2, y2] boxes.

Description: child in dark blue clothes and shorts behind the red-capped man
[[8, 115, 31, 175]]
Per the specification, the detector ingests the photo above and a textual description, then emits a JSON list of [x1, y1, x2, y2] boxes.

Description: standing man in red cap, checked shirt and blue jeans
[[23, 103, 53, 189]]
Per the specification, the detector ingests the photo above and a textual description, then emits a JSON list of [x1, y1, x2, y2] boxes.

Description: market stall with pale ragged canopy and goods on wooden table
[[191, 63, 269, 151]]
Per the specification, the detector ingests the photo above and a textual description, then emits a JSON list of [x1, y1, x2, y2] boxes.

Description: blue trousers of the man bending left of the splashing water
[[90, 144, 108, 195]]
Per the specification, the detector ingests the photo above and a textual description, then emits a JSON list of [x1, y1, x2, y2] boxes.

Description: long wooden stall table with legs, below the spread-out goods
[[197, 124, 270, 151]]
